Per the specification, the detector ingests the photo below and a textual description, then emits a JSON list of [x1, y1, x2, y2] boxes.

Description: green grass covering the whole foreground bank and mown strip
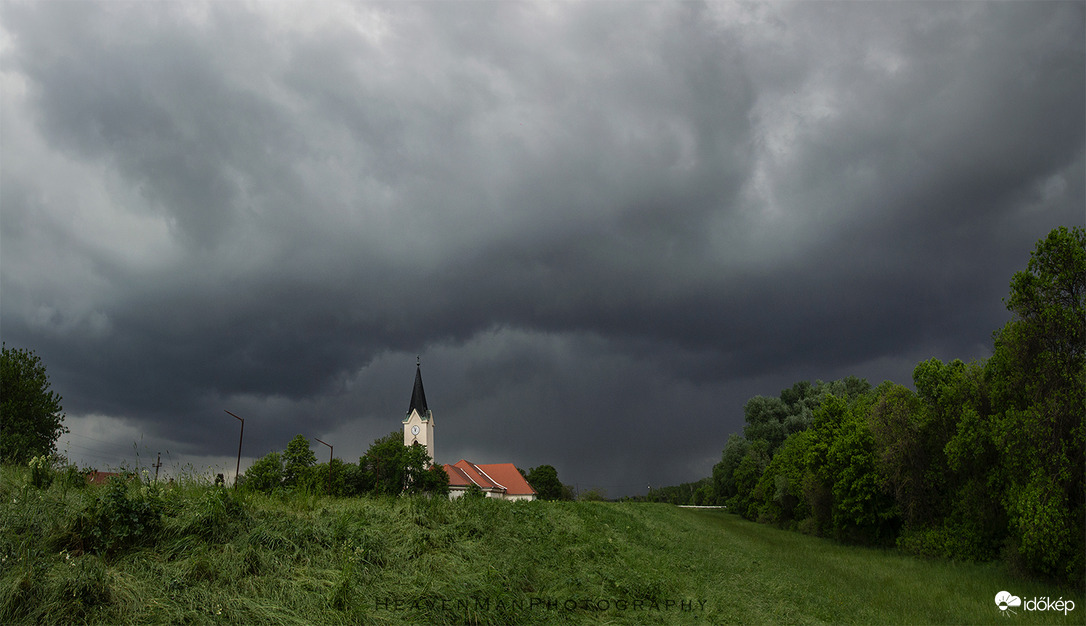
[[0, 468, 1086, 624]]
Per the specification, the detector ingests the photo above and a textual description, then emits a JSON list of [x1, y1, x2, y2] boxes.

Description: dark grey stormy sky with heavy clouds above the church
[[0, 0, 1086, 496]]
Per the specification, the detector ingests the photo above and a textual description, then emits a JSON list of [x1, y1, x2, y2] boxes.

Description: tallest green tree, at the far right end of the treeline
[[987, 227, 1086, 584]]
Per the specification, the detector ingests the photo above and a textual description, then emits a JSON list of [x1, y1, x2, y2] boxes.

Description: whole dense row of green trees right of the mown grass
[[712, 227, 1086, 585]]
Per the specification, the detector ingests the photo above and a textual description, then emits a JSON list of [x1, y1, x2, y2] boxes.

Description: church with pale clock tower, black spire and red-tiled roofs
[[403, 363, 535, 500]]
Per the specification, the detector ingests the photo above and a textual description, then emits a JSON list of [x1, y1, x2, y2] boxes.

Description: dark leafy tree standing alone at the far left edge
[[0, 345, 68, 464]]
